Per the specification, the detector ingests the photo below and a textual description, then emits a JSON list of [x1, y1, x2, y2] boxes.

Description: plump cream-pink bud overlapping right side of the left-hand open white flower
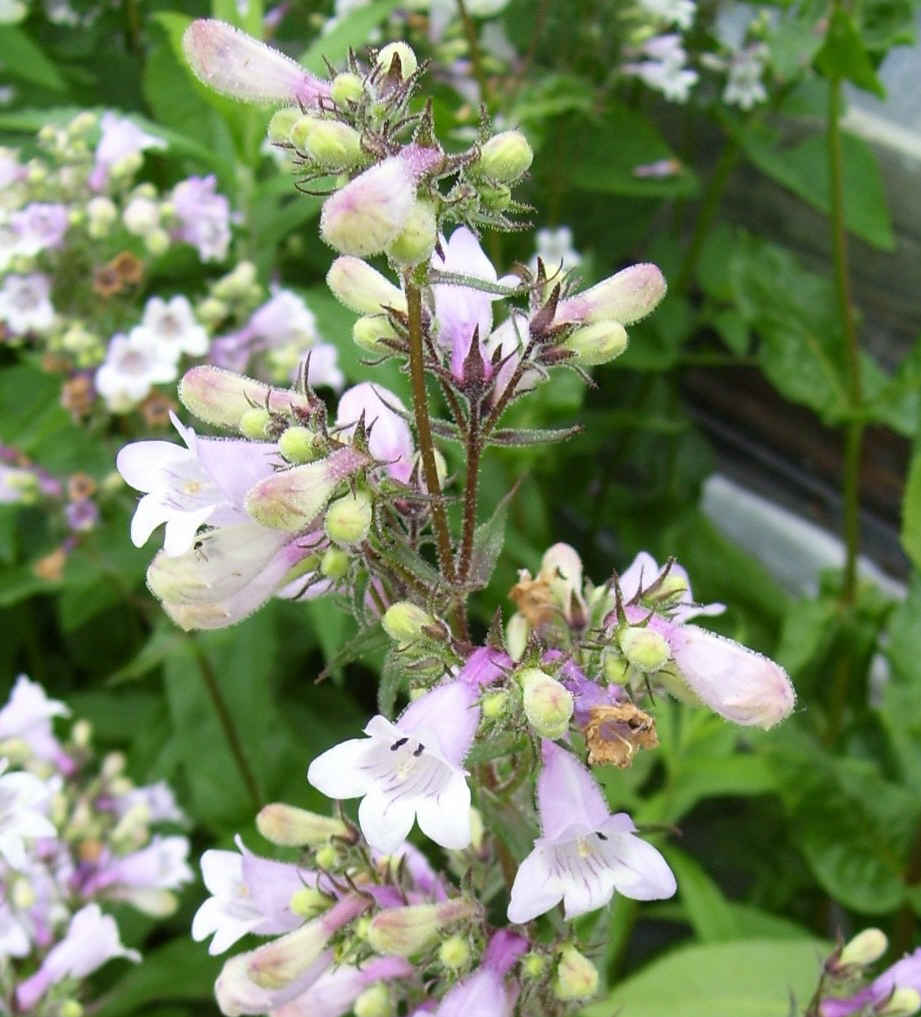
[[244, 447, 371, 533]]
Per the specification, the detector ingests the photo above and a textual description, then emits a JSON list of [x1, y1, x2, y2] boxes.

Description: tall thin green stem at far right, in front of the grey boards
[[826, 77, 863, 605]]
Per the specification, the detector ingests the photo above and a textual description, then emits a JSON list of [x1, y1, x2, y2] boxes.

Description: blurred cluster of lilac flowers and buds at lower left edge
[[0, 675, 192, 1017]]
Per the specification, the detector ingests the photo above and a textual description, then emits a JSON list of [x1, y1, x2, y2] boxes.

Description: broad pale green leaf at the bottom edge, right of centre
[[582, 940, 830, 1017]]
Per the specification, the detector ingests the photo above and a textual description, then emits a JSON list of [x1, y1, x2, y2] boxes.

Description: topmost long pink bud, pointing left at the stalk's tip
[[182, 18, 329, 106]]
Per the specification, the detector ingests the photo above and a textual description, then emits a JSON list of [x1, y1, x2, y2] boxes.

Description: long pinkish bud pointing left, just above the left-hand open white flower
[[179, 364, 310, 430]]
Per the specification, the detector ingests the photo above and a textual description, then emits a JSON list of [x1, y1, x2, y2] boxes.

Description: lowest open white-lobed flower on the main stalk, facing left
[[192, 835, 323, 955]]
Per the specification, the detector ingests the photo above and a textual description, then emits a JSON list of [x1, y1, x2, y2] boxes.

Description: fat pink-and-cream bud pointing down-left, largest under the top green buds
[[320, 156, 416, 257]]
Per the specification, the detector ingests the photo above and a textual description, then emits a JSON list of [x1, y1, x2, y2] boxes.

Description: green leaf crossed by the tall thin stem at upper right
[[730, 124, 896, 251]]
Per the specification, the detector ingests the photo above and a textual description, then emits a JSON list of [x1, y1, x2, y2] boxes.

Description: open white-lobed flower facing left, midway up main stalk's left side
[[115, 413, 281, 557]]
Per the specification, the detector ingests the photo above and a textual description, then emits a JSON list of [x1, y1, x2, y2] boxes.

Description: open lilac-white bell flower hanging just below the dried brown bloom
[[508, 738, 676, 922]]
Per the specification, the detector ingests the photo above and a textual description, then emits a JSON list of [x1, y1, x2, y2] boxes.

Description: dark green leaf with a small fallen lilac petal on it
[[566, 105, 698, 197]]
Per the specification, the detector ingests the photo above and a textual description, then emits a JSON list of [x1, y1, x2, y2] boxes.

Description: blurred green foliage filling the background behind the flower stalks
[[0, 0, 921, 1017]]
